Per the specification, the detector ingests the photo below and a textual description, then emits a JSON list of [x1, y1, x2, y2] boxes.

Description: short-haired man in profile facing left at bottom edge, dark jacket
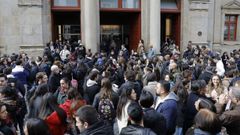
[[75, 105, 113, 135]]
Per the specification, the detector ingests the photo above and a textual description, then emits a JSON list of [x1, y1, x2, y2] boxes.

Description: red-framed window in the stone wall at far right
[[224, 15, 237, 41]]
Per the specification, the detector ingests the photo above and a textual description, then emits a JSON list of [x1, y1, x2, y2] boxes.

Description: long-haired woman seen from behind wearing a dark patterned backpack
[[93, 78, 119, 124]]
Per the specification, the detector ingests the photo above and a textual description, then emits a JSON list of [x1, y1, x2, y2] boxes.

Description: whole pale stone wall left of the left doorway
[[0, 0, 51, 55]]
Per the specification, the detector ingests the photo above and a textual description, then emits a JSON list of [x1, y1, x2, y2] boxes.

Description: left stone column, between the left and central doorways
[[81, 0, 100, 53]]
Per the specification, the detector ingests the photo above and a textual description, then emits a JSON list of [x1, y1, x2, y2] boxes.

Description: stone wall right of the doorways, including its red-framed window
[[181, 0, 240, 52]]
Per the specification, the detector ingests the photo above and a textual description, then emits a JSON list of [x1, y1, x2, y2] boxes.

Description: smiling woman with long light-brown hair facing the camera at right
[[207, 74, 228, 102]]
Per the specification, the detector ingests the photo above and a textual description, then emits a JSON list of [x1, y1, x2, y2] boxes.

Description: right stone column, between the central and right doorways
[[150, 0, 161, 54]]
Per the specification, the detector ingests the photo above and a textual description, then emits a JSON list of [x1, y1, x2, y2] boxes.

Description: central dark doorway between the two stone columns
[[100, 11, 141, 50]]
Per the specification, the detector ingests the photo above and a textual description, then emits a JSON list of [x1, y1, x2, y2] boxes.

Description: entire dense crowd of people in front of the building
[[0, 39, 240, 135]]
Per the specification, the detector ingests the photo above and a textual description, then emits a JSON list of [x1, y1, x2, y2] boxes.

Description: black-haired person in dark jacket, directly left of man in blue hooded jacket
[[139, 90, 166, 135]]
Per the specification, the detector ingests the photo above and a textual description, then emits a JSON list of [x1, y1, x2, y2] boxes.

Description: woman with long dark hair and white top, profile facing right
[[114, 85, 137, 134]]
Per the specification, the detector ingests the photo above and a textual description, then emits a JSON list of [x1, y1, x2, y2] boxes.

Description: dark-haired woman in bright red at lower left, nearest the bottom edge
[[39, 93, 67, 135]]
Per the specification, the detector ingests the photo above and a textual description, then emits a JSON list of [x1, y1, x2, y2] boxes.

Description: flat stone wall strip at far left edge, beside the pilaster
[[0, 0, 21, 54]]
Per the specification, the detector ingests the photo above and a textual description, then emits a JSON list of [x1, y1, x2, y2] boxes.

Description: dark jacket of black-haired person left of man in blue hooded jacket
[[143, 108, 167, 135]]
